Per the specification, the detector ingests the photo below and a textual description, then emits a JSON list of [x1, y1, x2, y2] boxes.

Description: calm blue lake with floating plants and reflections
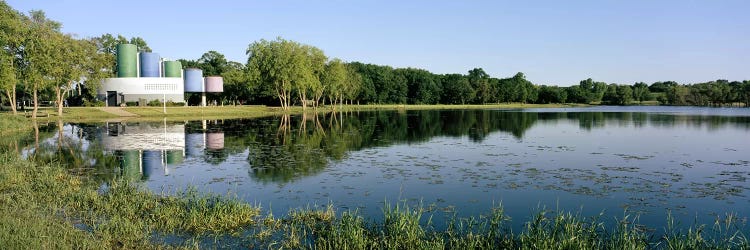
[[21, 107, 750, 231]]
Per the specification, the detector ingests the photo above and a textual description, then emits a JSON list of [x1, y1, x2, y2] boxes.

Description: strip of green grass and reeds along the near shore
[[0, 153, 750, 249]]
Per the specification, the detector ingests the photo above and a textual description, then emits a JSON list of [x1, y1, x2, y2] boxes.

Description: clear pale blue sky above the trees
[[7, 0, 750, 86]]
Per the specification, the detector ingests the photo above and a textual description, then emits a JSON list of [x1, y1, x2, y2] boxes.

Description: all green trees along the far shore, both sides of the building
[[0, 1, 750, 117]]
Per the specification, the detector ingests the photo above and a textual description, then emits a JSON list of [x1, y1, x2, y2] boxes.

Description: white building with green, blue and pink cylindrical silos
[[97, 44, 224, 107]]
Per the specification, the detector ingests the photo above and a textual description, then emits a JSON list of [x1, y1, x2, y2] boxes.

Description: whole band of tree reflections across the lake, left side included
[[7, 110, 750, 186]]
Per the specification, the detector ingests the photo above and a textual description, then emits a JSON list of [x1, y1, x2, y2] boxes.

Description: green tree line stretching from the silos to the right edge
[[172, 38, 750, 108]]
